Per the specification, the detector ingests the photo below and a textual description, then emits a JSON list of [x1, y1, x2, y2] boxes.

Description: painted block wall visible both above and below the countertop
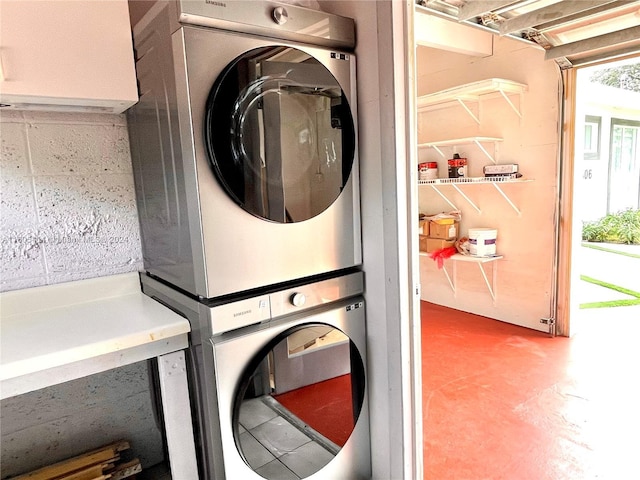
[[0, 110, 164, 479]]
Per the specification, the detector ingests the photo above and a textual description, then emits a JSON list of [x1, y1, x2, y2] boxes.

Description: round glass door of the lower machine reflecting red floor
[[233, 324, 365, 480]]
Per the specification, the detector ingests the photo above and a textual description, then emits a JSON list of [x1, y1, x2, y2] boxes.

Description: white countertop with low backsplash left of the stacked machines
[[0, 272, 190, 398]]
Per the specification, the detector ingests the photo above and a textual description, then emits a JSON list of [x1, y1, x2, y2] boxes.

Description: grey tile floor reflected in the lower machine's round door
[[240, 397, 335, 480]]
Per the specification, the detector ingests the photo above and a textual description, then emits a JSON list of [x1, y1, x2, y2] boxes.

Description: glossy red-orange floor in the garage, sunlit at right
[[422, 303, 640, 480]]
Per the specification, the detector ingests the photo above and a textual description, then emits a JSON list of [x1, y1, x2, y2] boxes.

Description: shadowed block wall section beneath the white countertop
[[0, 362, 164, 479]]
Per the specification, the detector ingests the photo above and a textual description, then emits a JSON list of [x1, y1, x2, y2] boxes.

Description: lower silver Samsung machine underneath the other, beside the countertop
[[141, 272, 371, 480]]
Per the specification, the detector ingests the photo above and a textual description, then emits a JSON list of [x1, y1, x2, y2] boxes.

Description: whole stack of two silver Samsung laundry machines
[[127, 0, 371, 480]]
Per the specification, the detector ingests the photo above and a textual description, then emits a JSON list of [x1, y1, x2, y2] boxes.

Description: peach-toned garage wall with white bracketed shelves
[[416, 21, 560, 332]]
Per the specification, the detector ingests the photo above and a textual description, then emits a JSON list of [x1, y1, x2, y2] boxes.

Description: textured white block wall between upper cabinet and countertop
[[0, 111, 142, 291]]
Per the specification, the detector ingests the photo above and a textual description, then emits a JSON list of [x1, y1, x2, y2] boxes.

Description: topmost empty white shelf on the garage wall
[[418, 78, 528, 111]]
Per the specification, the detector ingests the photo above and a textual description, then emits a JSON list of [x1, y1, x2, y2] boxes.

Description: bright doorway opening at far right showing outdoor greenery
[[569, 56, 640, 335]]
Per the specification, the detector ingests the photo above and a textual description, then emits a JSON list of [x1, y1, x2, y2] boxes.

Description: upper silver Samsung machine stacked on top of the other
[[127, 0, 362, 298]]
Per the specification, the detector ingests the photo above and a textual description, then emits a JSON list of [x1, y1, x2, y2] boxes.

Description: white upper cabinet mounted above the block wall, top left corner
[[0, 0, 138, 113]]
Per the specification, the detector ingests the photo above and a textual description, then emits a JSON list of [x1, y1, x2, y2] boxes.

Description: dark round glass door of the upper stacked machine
[[204, 46, 355, 223]]
